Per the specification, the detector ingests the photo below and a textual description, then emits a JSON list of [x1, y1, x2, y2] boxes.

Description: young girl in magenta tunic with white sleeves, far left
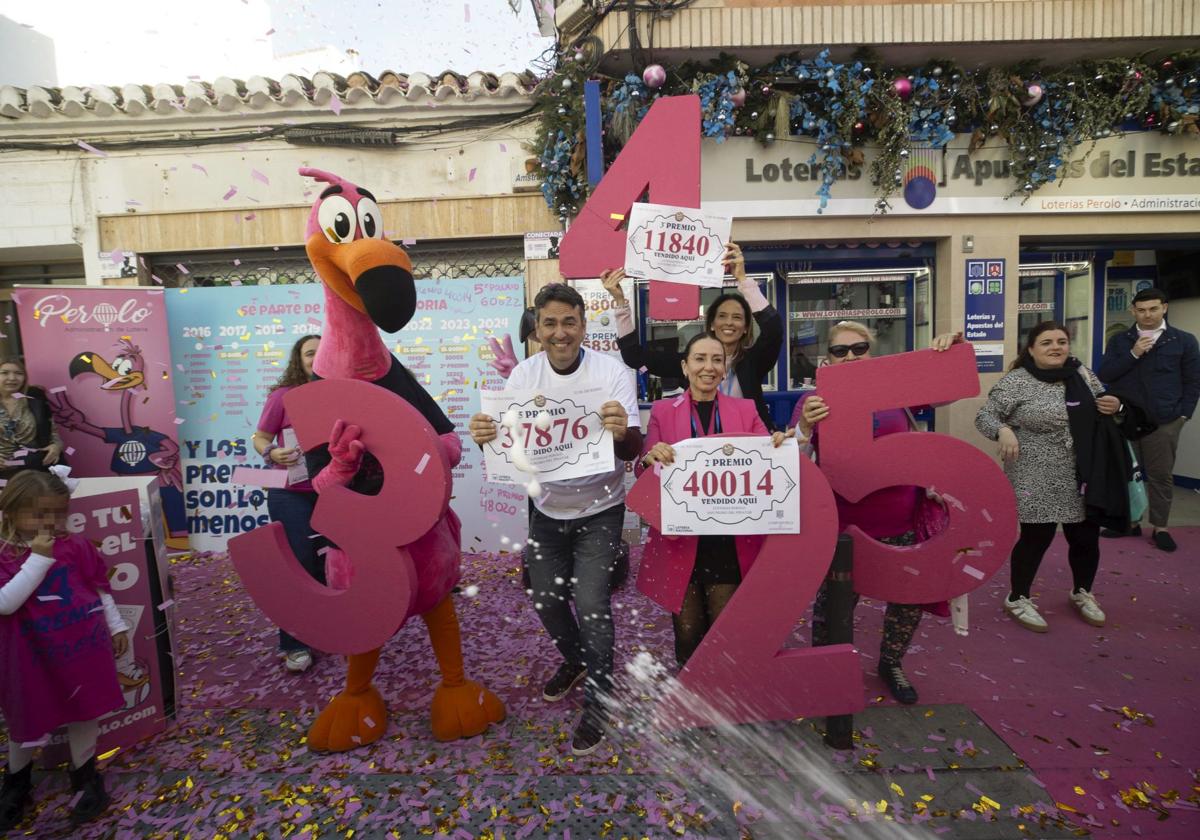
[[0, 468, 130, 832]]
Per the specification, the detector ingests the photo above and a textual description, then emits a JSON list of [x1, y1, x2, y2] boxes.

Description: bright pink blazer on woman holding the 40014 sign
[[635, 394, 769, 612]]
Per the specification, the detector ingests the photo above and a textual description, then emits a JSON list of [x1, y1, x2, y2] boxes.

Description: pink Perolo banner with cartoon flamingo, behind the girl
[[12, 287, 187, 538]]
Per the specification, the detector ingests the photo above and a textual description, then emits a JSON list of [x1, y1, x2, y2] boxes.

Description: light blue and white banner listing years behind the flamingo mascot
[[167, 277, 528, 551]]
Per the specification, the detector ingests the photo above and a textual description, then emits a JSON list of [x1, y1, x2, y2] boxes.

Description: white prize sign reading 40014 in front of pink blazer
[[660, 437, 800, 536]]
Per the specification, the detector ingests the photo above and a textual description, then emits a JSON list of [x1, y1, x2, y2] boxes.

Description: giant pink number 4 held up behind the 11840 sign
[[558, 96, 700, 320]]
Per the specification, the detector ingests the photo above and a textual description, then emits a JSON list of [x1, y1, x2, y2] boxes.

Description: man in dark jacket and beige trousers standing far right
[[1098, 289, 1200, 551]]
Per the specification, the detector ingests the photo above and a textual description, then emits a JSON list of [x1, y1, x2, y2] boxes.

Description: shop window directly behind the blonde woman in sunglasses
[[787, 268, 932, 381]]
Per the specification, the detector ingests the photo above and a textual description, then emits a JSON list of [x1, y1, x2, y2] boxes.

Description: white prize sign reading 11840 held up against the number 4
[[625, 204, 732, 289]]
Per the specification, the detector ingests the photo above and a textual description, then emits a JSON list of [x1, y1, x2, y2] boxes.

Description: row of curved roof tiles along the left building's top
[[0, 71, 536, 119]]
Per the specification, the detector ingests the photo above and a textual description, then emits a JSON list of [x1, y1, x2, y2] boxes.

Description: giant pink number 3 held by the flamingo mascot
[[229, 379, 450, 654]]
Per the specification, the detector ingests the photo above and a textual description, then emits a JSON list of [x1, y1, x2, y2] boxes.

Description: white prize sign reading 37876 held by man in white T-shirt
[[480, 385, 613, 484]]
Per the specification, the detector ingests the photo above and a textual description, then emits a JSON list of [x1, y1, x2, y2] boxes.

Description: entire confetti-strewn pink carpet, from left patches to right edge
[[162, 528, 1200, 840]]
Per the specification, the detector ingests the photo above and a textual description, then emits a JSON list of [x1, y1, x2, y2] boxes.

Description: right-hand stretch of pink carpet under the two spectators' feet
[[888, 528, 1200, 840]]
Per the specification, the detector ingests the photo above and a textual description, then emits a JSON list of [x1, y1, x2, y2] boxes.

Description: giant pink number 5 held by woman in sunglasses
[[817, 344, 1016, 604]]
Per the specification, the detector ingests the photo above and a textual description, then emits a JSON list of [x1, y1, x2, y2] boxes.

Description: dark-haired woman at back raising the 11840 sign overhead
[[600, 242, 784, 431]]
